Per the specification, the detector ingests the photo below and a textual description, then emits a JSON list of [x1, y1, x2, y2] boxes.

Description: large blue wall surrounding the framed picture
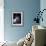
[[4, 0, 40, 41]]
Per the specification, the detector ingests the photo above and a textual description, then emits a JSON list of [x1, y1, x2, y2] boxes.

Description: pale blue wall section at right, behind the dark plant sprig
[[40, 0, 46, 27]]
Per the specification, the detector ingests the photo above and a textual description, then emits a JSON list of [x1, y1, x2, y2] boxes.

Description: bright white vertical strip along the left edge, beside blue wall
[[0, 0, 4, 42]]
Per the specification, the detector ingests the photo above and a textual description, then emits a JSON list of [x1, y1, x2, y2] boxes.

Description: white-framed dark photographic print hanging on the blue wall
[[12, 12, 23, 26]]
